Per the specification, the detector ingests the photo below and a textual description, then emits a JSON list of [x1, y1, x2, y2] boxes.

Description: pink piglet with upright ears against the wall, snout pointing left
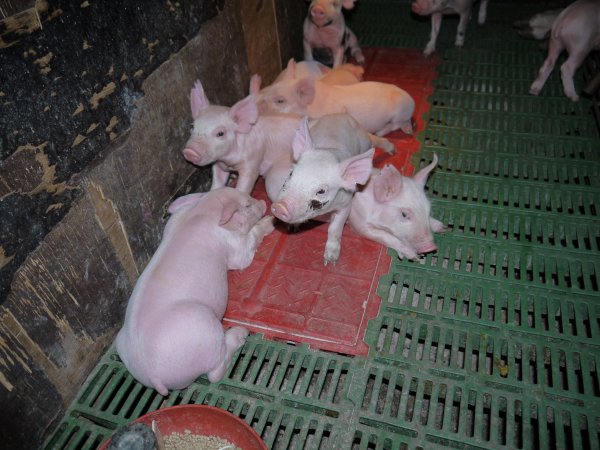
[[183, 81, 300, 194]]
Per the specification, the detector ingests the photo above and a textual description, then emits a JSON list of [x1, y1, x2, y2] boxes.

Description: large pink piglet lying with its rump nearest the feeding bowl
[[116, 187, 273, 395]]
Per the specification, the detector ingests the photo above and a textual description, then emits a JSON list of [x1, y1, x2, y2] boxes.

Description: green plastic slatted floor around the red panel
[[46, 0, 600, 450]]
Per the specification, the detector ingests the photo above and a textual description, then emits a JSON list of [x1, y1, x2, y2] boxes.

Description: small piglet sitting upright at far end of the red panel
[[303, 0, 365, 67]]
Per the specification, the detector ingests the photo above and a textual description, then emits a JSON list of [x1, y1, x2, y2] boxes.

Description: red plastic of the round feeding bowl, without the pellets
[[99, 405, 267, 450]]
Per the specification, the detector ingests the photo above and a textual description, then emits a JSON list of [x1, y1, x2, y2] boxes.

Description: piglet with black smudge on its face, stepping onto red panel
[[267, 114, 375, 265]]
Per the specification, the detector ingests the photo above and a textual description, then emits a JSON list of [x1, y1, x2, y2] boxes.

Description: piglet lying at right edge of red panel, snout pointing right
[[349, 155, 444, 259]]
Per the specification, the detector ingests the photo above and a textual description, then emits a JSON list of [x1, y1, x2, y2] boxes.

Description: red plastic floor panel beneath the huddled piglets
[[223, 48, 439, 356]]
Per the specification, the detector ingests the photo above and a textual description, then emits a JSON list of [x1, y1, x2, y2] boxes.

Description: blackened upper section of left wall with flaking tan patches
[[0, 0, 224, 303]]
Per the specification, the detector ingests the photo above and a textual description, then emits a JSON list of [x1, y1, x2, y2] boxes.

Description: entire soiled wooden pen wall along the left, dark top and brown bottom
[[0, 0, 305, 449]]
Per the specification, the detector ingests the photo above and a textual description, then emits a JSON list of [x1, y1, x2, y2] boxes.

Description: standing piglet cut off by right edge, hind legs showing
[[529, 0, 600, 102]]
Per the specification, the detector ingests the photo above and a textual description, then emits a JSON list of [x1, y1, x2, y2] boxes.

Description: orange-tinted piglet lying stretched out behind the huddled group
[[257, 77, 415, 136]]
